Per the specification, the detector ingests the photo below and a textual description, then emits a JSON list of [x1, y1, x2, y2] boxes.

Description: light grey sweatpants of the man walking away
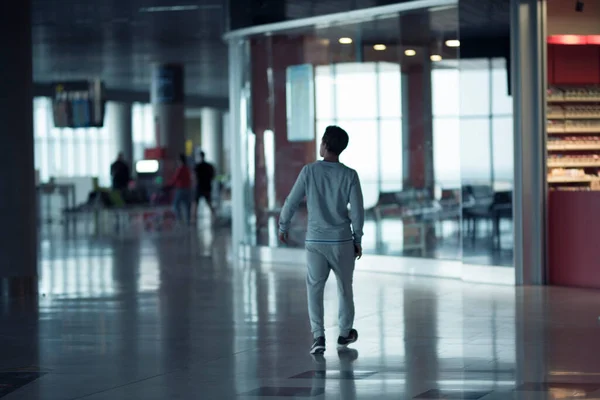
[[306, 241, 356, 338]]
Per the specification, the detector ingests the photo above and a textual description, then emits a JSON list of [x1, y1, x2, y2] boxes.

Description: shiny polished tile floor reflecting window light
[[0, 227, 600, 400]]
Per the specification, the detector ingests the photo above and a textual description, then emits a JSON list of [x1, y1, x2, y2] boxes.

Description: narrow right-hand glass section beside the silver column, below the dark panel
[[459, 59, 514, 266]]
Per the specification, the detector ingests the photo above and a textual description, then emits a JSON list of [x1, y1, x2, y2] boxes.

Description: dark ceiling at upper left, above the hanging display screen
[[33, 0, 228, 104]]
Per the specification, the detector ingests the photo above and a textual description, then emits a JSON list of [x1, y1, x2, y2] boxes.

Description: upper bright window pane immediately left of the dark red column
[[378, 63, 402, 118]]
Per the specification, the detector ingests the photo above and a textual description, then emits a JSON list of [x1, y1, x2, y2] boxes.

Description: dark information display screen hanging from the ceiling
[[52, 80, 105, 128]]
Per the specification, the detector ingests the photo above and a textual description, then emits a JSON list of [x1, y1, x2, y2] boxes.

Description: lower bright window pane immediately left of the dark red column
[[379, 119, 402, 192]]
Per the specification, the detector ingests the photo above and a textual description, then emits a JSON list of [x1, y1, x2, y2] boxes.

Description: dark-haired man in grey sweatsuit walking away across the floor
[[279, 126, 364, 354]]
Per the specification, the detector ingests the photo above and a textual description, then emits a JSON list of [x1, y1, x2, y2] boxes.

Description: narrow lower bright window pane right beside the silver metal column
[[492, 117, 514, 190]]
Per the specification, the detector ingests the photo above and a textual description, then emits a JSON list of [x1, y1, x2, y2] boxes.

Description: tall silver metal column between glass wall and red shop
[[511, 0, 547, 285]]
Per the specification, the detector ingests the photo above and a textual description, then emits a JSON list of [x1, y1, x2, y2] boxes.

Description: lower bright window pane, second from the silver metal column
[[460, 118, 491, 184]]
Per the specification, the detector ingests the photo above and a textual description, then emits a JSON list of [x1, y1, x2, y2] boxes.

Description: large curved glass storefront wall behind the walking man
[[233, 4, 512, 265]]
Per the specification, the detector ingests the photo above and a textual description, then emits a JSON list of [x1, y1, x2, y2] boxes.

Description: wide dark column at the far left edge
[[0, 0, 38, 297]]
